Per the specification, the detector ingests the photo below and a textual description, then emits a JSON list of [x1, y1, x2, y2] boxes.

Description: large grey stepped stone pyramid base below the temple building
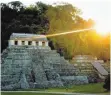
[[1, 46, 88, 90]]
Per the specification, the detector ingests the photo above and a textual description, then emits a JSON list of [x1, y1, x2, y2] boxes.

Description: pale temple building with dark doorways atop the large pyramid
[[9, 33, 48, 46]]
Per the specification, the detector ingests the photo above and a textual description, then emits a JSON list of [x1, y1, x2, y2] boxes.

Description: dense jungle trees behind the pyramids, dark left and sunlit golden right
[[1, 1, 110, 61]]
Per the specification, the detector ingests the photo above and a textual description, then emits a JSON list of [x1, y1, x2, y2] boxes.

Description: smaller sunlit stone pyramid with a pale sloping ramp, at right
[[70, 55, 110, 83]]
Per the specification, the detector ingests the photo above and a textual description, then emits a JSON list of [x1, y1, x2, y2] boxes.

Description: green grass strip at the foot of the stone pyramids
[[1, 83, 110, 95]]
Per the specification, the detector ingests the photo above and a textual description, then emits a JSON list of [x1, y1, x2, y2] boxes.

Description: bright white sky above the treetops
[[0, 0, 111, 31]]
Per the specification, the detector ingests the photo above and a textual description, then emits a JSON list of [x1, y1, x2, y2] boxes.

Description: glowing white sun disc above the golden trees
[[94, 23, 111, 36]]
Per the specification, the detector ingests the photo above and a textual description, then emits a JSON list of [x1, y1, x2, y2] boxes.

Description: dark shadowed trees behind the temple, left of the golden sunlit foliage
[[1, 1, 49, 50]]
